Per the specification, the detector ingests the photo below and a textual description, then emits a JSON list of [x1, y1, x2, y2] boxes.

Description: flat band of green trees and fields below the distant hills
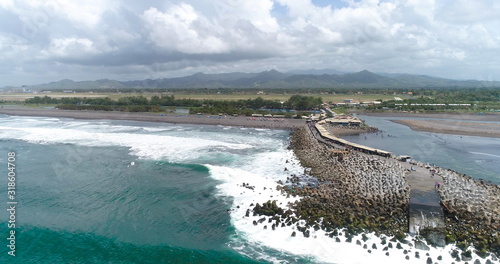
[[11, 88, 500, 116]]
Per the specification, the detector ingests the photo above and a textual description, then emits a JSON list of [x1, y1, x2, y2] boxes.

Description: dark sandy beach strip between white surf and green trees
[[0, 106, 305, 130]]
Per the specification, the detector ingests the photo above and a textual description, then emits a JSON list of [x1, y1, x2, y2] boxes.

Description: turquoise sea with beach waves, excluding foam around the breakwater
[[0, 116, 296, 263]]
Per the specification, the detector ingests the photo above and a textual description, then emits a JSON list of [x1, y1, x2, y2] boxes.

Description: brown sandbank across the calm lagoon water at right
[[391, 119, 500, 137]]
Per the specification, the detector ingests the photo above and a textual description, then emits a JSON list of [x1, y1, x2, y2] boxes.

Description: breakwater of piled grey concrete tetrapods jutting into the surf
[[282, 124, 500, 261]]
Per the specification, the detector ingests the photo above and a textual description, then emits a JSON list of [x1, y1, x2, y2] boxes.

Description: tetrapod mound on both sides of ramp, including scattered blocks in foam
[[246, 126, 500, 263]]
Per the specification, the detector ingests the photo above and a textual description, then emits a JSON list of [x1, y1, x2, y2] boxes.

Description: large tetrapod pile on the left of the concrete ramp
[[291, 127, 410, 236]]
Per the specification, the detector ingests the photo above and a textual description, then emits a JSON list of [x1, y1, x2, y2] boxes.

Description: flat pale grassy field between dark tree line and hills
[[0, 93, 394, 102]]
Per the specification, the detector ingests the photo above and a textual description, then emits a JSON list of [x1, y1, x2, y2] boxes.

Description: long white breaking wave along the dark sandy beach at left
[[0, 118, 254, 162]]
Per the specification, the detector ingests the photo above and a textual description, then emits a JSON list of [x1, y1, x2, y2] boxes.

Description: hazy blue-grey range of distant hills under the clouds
[[8, 69, 500, 90]]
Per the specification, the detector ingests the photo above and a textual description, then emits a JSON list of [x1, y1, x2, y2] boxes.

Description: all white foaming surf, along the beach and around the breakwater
[[0, 117, 488, 264]]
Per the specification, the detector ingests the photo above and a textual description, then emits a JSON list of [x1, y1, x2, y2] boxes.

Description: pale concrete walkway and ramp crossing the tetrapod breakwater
[[309, 123, 446, 246]]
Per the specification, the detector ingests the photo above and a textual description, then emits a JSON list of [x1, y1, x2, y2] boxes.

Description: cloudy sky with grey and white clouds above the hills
[[0, 0, 500, 87]]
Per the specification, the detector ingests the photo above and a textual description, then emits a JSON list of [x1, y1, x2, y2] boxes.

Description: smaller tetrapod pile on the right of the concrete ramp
[[434, 167, 500, 256]]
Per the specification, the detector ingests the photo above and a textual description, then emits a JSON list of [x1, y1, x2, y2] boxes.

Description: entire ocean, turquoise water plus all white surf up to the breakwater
[[0, 115, 500, 263]]
